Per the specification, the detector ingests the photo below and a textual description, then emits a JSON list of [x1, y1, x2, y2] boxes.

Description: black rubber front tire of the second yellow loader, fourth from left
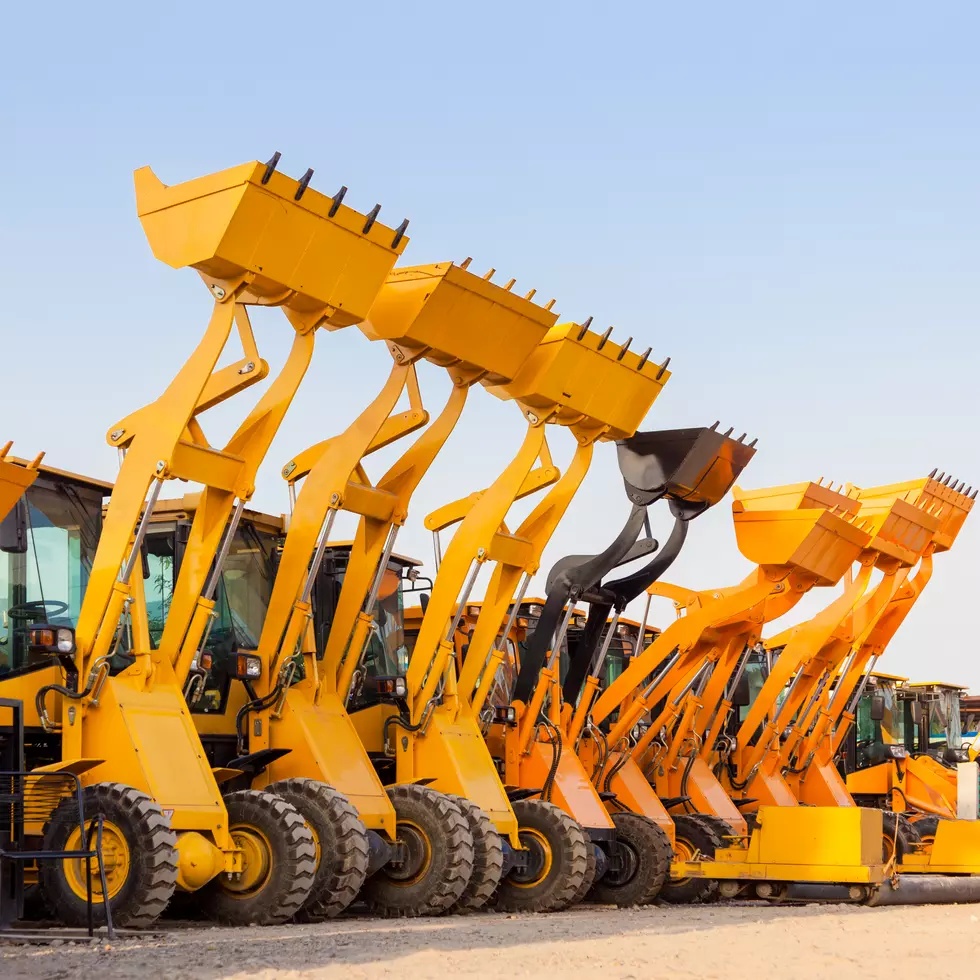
[[361, 784, 473, 918]]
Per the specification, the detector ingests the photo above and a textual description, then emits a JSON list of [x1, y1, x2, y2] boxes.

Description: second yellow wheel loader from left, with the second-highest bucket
[[180, 261, 555, 917]]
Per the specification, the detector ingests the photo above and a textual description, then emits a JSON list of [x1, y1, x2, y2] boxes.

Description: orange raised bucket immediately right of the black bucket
[[732, 483, 872, 585]]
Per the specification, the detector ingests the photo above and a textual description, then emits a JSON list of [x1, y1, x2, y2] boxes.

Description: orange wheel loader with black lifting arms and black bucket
[[467, 429, 753, 905]]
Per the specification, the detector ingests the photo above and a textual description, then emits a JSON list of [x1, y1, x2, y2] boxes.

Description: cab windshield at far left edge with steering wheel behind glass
[[0, 477, 103, 674]]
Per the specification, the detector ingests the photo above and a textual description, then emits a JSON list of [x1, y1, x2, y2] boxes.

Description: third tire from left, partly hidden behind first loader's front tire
[[265, 778, 369, 922]]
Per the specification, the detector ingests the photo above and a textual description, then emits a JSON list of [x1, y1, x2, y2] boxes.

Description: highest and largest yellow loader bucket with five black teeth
[[134, 155, 408, 327]]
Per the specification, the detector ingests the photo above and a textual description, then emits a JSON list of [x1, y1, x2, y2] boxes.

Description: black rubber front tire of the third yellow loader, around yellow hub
[[497, 800, 592, 912]]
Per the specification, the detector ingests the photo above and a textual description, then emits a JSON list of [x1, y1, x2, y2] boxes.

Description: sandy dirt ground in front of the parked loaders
[[0, 905, 980, 980]]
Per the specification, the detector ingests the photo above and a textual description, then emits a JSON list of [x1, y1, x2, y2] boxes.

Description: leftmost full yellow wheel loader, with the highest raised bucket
[[0, 154, 405, 926]]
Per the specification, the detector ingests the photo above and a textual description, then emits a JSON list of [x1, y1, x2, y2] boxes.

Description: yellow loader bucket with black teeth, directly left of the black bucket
[[490, 323, 670, 439]]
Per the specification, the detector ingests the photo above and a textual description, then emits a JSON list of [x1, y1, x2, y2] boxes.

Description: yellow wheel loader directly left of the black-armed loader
[[356, 322, 669, 911]]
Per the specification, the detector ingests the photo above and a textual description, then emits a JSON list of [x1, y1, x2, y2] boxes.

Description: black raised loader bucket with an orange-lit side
[[616, 423, 755, 512]]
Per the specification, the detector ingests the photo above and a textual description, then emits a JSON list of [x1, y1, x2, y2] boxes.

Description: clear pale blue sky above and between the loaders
[[0, 2, 980, 687]]
